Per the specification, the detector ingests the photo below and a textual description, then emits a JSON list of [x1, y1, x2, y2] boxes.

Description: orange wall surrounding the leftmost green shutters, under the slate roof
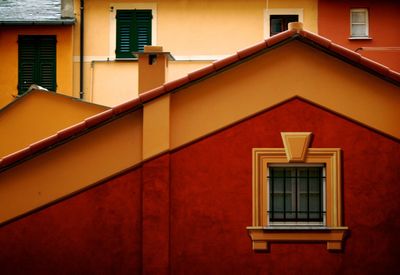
[[0, 26, 73, 108]]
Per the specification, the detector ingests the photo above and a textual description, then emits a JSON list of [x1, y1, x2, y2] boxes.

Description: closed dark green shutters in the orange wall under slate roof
[[18, 35, 56, 94]]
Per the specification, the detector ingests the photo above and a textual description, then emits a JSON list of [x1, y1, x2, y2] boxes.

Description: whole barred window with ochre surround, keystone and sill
[[247, 132, 348, 251]]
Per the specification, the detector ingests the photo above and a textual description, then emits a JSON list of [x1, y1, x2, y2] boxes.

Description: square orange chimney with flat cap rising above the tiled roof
[[133, 46, 174, 94]]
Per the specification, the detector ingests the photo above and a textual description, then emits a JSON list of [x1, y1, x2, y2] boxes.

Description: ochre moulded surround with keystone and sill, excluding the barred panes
[[247, 132, 348, 251]]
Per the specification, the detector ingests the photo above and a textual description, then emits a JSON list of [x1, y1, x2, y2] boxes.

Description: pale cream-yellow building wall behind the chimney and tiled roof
[[74, 0, 317, 106]]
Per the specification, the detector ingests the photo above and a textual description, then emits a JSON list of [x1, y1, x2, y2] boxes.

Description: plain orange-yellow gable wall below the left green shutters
[[0, 91, 107, 158]]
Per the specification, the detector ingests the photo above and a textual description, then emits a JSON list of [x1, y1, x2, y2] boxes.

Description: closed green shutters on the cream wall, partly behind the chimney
[[115, 10, 153, 58]]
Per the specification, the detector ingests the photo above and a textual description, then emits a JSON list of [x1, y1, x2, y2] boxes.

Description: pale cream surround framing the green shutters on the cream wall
[[108, 3, 157, 60]]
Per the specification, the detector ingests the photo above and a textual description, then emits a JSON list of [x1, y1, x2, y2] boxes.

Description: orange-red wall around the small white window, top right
[[318, 0, 400, 71]]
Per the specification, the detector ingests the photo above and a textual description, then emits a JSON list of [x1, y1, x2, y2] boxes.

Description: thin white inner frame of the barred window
[[266, 163, 326, 229]]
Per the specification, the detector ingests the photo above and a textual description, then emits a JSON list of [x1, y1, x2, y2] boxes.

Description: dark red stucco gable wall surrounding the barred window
[[171, 100, 400, 274]]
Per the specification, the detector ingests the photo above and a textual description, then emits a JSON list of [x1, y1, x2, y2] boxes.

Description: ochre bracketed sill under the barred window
[[247, 226, 348, 251]]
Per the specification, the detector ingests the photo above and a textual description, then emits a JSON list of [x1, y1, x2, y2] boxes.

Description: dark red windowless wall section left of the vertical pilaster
[[0, 170, 141, 275]]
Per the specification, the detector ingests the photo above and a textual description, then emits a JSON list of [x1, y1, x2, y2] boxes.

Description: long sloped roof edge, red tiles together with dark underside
[[0, 26, 400, 172]]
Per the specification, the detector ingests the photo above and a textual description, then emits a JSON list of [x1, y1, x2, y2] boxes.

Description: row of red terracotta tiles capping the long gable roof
[[0, 27, 400, 170]]
